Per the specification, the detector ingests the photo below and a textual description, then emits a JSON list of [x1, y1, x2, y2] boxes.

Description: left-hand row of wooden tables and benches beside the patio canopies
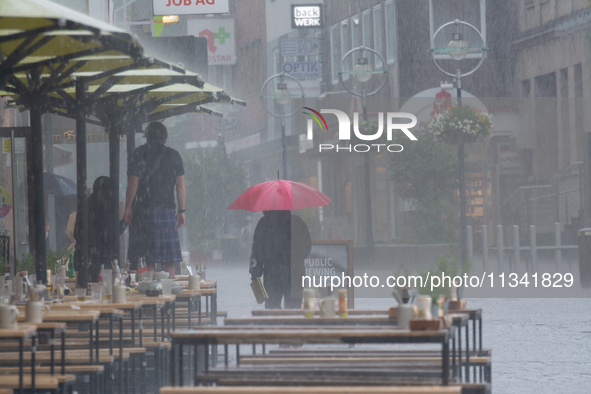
[[0, 272, 220, 394]]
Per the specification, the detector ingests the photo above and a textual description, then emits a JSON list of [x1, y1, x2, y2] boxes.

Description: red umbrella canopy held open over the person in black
[[228, 180, 332, 212]]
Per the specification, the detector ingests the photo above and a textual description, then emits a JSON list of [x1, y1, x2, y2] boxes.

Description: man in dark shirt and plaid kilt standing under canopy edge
[[124, 122, 185, 278]]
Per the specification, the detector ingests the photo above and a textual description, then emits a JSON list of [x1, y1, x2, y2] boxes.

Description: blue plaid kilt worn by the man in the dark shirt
[[129, 208, 183, 268]]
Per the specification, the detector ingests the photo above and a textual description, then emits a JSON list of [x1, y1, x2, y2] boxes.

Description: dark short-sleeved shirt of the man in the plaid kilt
[[127, 142, 185, 209]]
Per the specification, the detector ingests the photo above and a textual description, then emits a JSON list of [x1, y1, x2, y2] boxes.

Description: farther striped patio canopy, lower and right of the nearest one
[[0, 66, 246, 127]]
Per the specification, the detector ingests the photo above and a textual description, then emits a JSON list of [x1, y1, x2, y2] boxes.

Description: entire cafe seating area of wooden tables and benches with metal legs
[[0, 264, 492, 394]]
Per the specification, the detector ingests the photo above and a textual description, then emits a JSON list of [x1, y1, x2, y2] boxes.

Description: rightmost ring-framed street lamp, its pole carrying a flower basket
[[430, 19, 488, 268]]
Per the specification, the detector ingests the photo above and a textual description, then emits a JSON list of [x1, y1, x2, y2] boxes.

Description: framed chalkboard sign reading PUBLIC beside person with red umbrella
[[304, 241, 354, 309]]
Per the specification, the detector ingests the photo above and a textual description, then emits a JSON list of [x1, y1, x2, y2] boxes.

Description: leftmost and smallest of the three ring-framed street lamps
[[260, 73, 304, 179]]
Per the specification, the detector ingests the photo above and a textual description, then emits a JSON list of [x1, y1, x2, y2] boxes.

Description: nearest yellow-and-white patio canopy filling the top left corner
[[0, 0, 148, 90]]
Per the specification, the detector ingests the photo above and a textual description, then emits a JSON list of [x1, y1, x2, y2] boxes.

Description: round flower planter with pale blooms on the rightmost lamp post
[[425, 104, 493, 144]]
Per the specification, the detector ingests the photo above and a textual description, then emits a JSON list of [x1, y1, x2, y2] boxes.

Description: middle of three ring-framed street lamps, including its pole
[[339, 45, 388, 257]]
